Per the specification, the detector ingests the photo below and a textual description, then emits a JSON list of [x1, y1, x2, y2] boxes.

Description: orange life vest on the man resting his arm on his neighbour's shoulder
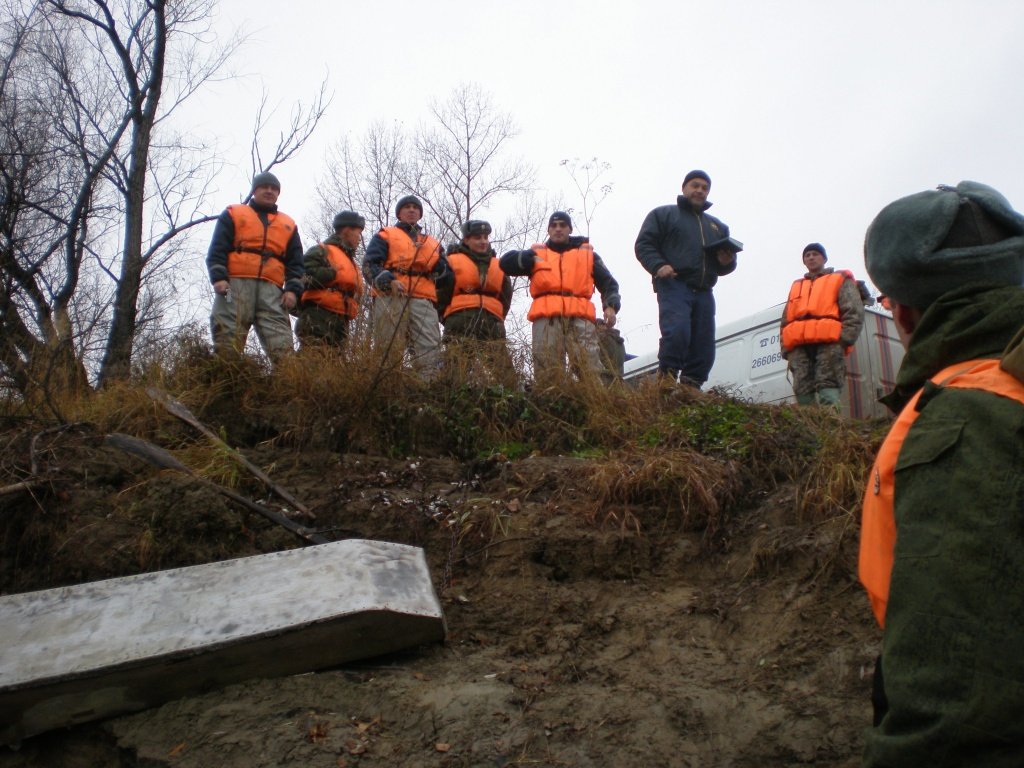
[[526, 243, 597, 321]]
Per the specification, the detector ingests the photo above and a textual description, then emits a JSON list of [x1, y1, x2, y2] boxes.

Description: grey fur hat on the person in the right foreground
[[864, 181, 1024, 309]]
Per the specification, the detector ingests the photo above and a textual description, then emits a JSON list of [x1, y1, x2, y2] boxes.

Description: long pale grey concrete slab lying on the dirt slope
[[0, 540, 445, 743]]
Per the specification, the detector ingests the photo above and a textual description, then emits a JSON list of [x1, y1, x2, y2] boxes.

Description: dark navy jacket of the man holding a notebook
[[635, 195, 736, 290]]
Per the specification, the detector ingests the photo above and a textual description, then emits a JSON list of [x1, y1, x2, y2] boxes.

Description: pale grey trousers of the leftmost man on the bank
[[210, 278, 295, 360]]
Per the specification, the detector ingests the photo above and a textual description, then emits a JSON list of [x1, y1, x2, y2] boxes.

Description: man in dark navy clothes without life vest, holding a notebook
[[635, 170, 736, 388]]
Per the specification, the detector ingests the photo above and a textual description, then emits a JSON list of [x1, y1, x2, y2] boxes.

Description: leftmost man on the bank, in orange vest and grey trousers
[[206, 172, 303, 359]]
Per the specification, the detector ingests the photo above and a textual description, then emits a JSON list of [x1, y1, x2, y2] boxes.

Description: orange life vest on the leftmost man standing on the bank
[[227, 204, 295, 288]]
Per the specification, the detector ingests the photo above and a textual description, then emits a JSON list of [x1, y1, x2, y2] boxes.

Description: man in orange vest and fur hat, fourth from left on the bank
[[437, 219, 514, 384]]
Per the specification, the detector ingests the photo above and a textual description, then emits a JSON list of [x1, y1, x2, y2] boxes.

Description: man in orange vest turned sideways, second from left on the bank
[[295, 211, 367, 346]]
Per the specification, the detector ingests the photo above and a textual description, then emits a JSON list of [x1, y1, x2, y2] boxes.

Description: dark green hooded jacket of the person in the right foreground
[[863, 286, 1024, 768]]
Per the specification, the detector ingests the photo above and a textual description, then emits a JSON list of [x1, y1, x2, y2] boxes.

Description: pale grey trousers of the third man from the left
[[370, 295, 441, 378]]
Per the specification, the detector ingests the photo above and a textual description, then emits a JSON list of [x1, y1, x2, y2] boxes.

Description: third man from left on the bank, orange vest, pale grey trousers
[[362, 195, 447, 377]]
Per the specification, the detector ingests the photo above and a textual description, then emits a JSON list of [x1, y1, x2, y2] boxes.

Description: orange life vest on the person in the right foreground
[[857, 359, 1024, 628]]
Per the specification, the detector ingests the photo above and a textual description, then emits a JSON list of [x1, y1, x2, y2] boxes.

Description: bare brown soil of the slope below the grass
[[0, 430, 879, 768]]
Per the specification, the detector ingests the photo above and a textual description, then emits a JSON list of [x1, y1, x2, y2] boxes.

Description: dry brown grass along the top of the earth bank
[[4, 330, 878, 549]]
